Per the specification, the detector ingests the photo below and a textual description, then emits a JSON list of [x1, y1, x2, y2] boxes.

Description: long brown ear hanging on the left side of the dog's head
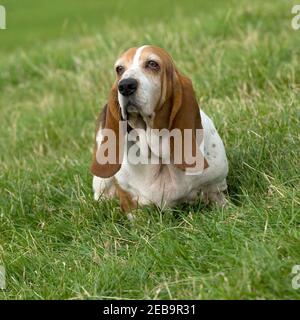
[[91, 84, 125, 178]]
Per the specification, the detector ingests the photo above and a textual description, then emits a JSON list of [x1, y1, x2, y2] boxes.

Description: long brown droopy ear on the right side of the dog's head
[[154, 69, 209, 174]]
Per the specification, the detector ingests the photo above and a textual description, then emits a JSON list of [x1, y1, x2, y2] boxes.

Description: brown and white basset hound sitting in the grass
[[91, 45, 228, 214]]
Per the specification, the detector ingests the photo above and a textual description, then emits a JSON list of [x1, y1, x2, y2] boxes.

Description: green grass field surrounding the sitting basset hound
[[0, 0, 300, 299]]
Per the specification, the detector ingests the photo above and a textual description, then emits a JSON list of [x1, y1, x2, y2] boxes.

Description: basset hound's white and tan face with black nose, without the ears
[[115, 46, 173, 124]]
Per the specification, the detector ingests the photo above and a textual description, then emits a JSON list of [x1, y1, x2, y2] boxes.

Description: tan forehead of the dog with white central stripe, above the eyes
[[115, 45, 170, 68]]
